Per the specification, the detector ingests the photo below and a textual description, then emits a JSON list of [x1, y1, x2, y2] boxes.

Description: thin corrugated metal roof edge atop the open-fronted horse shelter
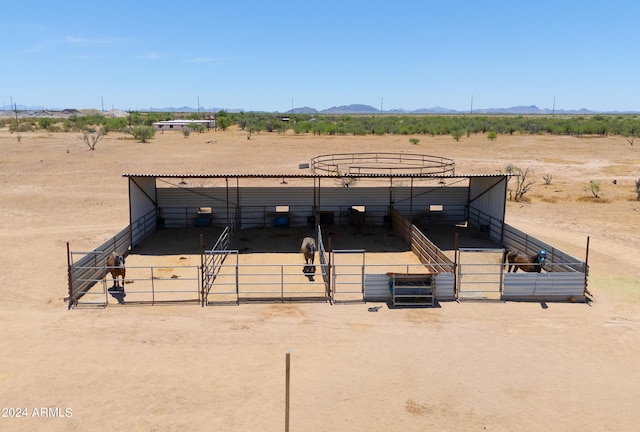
[[122, 173, 512, 179]]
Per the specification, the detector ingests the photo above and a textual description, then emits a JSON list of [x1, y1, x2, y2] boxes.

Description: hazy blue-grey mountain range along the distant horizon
[[0, 104, 640, 115]]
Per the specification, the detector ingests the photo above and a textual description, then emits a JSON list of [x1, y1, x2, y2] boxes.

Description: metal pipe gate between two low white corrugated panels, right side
[[457, 248, 504, 300]]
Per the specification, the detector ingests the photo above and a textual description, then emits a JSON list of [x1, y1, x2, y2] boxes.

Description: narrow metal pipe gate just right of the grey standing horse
[[331, 249, 365, 302]]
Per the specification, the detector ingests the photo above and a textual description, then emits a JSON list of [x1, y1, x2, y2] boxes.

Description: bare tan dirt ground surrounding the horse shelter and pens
[[0, 124, 640, 432]]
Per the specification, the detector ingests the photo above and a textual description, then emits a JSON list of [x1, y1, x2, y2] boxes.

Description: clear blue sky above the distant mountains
[[0, 0, 640, 112]]
